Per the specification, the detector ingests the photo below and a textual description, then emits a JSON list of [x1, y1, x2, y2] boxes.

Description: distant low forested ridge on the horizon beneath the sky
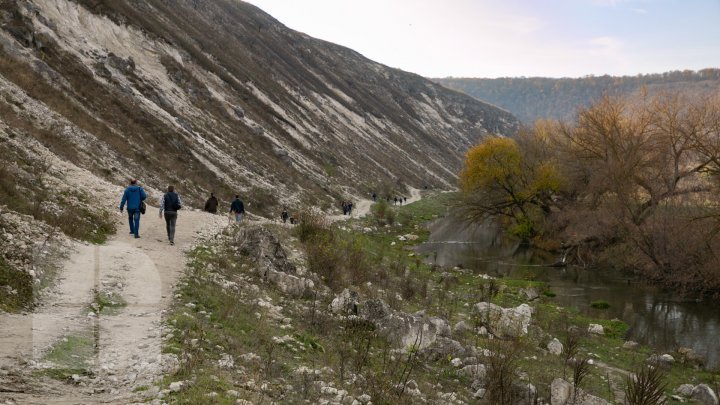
[[433, 69, 720, 124]]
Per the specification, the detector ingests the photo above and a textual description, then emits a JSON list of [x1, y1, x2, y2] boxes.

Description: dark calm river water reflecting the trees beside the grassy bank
[[418, 217, 720, 368]]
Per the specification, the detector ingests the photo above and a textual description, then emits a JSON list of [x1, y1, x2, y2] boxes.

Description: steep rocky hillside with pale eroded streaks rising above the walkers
[[0, 0, 516, 217]]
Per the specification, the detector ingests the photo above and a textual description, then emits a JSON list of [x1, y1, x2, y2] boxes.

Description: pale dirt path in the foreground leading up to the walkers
[[0, 207, 227, 404]]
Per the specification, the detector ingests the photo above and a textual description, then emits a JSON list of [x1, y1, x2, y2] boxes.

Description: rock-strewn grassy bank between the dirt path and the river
[[135, 193, 720, 403]]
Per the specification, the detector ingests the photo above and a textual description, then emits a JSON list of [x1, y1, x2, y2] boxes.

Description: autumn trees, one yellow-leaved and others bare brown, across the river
[[461, 93, 720, 297]]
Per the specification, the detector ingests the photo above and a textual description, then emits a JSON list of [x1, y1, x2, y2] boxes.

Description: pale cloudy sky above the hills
[[248, 0, 720, 78]]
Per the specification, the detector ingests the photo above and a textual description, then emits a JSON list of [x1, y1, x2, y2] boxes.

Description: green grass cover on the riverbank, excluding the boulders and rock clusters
[[160, 194, 718, 403]]
